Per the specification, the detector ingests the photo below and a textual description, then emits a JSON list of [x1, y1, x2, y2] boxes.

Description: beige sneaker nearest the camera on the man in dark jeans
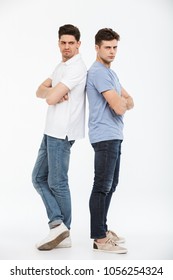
[[93, 238, 127, 254]]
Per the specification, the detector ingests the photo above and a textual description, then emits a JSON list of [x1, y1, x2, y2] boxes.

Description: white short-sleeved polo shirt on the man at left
[[44, 54, 87, 141]]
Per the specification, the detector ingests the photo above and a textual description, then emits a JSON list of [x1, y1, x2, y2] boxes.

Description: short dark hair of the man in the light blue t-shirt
[[95, 28, 120, 46]]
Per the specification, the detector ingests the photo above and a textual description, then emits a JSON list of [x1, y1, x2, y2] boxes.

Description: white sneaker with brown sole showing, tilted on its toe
[[36, 223, 69, 250]]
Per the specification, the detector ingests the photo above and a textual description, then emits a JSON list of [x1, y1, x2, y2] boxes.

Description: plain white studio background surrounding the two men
[[0, 0, 173, 260]]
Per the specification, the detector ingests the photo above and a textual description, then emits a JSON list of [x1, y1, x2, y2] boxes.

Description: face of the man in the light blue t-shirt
[[96, 39, 118, 66]]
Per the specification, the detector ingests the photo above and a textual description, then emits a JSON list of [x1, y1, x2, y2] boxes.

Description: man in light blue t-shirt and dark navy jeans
[[86, 28, 134, 253]]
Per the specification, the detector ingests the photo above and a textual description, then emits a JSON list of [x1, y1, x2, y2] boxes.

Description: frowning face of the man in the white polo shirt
[[59, 35, 80, 61]]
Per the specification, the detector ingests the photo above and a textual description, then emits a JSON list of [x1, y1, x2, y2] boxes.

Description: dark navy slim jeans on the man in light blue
[[89, 140, 122, 239]]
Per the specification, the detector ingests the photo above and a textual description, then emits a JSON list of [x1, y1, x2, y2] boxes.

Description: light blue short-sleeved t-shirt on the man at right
[[86, 61, 124, 143]]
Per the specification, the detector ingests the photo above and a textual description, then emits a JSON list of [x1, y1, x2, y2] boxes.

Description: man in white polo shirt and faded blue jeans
[[32, 24, 87, 250]]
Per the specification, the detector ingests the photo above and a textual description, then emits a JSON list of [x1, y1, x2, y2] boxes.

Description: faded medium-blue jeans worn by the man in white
[[32, 135, 74, 229]]
